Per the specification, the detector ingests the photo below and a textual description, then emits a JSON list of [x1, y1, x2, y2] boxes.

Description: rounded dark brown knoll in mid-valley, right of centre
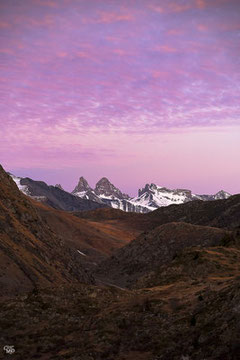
[[96, 223, 231, 286]]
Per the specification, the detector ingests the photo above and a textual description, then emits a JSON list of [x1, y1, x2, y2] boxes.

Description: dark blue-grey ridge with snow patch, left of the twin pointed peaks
[[9, 174, 106, 211]]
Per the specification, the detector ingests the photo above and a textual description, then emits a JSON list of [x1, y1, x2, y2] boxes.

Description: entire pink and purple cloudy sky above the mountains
[[0, 0, 240, 195]]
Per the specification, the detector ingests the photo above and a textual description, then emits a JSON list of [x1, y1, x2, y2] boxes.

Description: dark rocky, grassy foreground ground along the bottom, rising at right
[[0, 243, 240, 360]]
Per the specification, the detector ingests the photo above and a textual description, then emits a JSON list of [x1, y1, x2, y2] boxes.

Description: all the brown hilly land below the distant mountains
[[0, 168, 240, 360]]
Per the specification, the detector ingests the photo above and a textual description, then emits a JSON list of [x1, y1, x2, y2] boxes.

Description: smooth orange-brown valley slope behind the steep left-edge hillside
[[31, 200, 141, 262]]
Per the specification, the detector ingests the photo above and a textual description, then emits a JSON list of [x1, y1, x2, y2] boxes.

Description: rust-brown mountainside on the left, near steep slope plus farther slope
[[0, 168, 141, 294]]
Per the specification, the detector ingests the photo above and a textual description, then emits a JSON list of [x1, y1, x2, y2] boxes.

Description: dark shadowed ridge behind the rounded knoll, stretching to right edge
[[74, 195, 240, 235]]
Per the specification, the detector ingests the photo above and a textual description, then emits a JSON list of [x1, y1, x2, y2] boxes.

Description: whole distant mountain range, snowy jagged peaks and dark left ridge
[[10, 174, 231, 213]]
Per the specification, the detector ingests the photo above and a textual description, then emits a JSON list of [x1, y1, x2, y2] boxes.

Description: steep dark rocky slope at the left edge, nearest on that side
[[0, 166, 94, 295]]
